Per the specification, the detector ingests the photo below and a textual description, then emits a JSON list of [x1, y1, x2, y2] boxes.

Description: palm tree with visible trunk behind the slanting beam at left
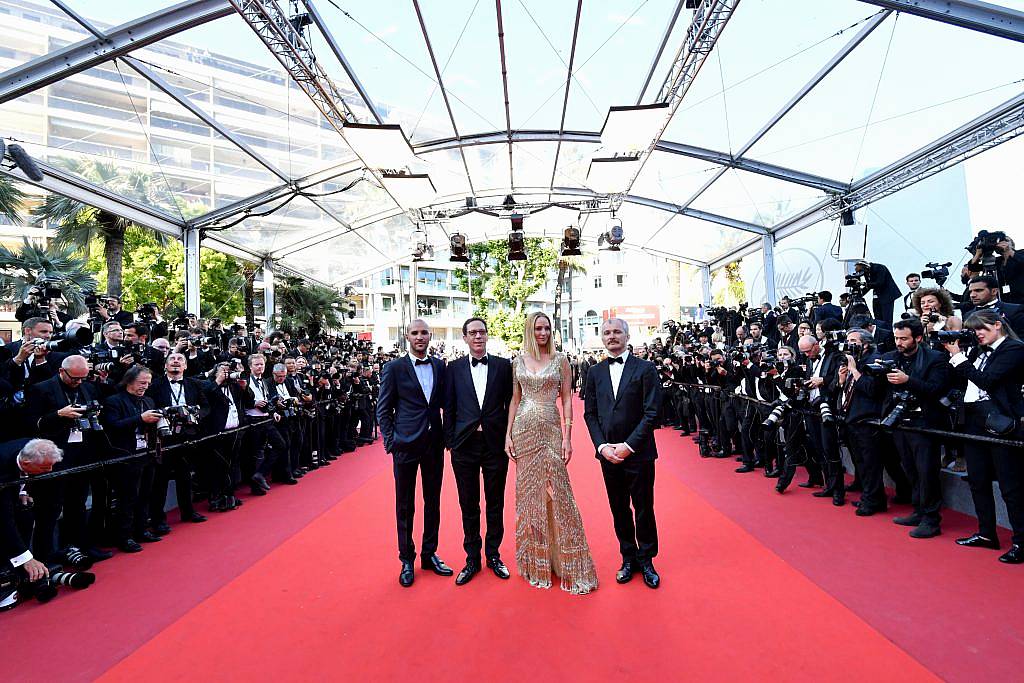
[[32, 159, 168, 296]]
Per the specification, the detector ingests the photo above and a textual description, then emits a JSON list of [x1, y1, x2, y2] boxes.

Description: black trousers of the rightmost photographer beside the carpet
[[964, 400, 1024, 544]]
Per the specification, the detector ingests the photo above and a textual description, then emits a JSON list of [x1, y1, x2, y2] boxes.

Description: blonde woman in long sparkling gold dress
[[505, 311, 597, 594]]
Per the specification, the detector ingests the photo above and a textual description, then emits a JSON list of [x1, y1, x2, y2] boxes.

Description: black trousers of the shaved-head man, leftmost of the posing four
[[394, 435, 444, 562]]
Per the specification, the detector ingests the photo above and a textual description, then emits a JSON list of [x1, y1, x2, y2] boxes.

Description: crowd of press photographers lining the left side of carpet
[[0, 282, 394, 609]]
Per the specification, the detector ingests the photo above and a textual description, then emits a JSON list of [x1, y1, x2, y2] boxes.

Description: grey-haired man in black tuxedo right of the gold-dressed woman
[[584, 317, 662, 588]]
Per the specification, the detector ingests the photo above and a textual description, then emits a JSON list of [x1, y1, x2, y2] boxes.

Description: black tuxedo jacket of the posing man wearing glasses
[[444, 354, 512, 453]]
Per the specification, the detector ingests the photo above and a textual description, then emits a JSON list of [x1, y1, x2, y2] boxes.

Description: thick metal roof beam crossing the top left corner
[[0, 0, 231, 104]]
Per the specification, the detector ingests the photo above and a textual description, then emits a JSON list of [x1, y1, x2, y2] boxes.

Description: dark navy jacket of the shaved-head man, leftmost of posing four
[[377, 355, 445, 464]]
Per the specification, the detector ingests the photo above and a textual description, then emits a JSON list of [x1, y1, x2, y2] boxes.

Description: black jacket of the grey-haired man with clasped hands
[[584, 353, 662, 464]]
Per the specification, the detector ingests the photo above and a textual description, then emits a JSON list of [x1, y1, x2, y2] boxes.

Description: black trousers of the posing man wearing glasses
[[452, 431, 509, 562]]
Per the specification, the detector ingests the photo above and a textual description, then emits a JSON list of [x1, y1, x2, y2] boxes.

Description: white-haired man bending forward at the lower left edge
[[0, 438, 61, 609]]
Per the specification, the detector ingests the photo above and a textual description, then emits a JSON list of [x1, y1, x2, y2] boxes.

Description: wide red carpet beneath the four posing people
[[0, 397, 1022, 681]]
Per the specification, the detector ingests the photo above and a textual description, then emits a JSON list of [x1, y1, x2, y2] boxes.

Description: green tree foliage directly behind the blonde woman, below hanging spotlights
[[455, 238, 558, 348]]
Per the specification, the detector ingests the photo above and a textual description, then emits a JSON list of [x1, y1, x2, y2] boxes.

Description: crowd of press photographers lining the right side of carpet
[[579, 231, 1024, 564]]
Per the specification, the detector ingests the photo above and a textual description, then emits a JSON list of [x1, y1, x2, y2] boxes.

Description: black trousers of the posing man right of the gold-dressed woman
[[601, 458, 657, 564]]
